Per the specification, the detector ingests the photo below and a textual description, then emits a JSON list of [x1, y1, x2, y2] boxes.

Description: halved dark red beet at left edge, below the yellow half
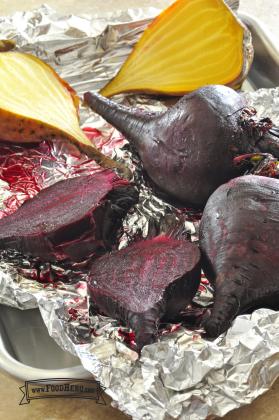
[[0, 170, 138, 261]]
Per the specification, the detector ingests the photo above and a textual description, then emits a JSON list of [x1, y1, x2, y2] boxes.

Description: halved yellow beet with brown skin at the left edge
[[0, 51, 126, 174]]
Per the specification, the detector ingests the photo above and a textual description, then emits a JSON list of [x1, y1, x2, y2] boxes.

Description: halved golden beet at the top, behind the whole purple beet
[[101, 0, 253, 96]]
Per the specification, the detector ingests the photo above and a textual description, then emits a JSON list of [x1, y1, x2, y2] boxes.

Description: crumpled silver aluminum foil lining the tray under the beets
[[0, 0, 279, 420]]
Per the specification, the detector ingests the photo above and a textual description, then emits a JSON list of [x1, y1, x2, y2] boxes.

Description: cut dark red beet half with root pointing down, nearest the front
[[88, 236, 201, 351]]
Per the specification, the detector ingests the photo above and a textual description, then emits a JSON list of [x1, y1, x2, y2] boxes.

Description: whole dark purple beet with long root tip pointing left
[[84, 85, 279, 208]]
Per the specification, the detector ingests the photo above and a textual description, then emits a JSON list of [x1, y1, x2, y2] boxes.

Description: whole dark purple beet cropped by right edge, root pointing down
[[200, 175, 279, 338]]
